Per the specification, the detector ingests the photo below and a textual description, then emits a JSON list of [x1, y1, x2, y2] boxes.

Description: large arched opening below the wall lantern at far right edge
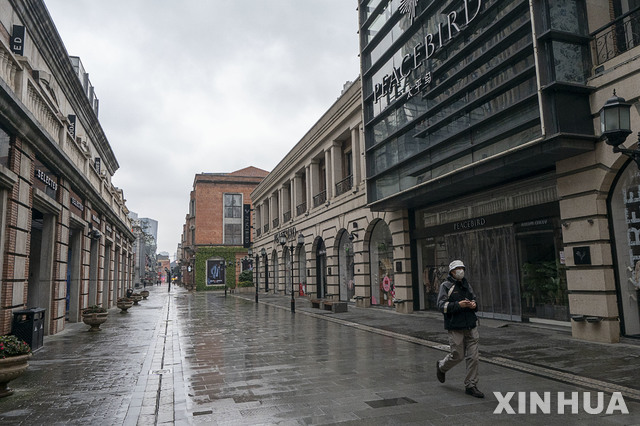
[[608, 161, 640, 336]]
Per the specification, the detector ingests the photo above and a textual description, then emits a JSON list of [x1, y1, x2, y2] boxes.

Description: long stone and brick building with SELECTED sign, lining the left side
[[0, 0, 134, 334]]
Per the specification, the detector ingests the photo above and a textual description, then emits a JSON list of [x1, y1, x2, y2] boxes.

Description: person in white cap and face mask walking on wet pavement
[[436, 260, 484, 398]]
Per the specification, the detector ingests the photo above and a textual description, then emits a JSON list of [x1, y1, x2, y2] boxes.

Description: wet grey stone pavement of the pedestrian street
[[0, 286, 640, 425]]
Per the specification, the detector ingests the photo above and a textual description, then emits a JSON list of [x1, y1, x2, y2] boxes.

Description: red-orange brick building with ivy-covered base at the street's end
[[178, 167, 269, 290]]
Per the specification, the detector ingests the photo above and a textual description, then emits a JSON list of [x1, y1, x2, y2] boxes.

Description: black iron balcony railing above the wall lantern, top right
[[589, 7, 640, 65]]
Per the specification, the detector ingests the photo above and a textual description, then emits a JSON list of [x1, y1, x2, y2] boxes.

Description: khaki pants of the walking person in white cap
[[438, 327, 480, 388]]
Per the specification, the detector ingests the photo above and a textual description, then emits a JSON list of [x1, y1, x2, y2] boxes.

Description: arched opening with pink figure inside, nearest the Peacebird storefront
[[369, 220, 396, 306]]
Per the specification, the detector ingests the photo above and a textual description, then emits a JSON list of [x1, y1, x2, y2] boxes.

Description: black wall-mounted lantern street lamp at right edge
[[600, 90, 640, 169]]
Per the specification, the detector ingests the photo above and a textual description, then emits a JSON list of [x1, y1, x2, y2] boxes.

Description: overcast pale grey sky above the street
[[45, 0, 359, 260]]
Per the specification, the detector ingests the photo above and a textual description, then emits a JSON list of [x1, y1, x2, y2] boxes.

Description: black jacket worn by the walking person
[[438, 275, 478, 330]]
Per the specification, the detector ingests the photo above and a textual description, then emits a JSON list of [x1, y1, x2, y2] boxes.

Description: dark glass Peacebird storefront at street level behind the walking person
[[414, 208, 569, 321]]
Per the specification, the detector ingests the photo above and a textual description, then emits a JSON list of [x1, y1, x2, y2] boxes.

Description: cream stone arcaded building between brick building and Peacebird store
[[252, 79, 412, 312]]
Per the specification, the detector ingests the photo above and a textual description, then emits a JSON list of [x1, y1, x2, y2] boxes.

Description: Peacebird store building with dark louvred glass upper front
[[359, 0, 640, 342]]
